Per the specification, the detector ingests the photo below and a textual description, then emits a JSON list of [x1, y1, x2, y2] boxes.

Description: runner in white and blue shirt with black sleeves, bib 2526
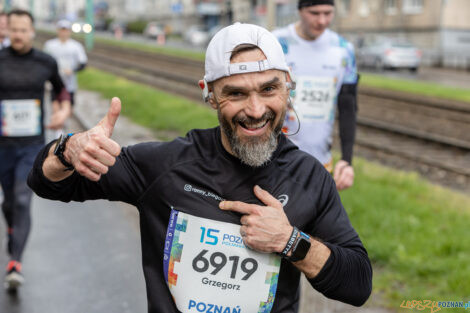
[[273, 0, 358, 190]]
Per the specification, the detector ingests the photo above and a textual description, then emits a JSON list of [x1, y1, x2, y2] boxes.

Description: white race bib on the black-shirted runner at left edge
[[0, 99, 42, 137]]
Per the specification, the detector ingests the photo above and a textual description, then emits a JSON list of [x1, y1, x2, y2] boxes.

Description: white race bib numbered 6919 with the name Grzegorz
[[163, 209, 281, 313]]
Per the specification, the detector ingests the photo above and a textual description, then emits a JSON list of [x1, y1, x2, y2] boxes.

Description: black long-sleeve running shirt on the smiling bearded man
[[28, 128, 372, 313]]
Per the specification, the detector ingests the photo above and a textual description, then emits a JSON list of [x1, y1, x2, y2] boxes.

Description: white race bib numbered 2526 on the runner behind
[[294, 76, 336, 121]]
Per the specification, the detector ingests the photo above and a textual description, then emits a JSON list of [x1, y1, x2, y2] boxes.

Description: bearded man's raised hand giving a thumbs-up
[[64, 98, 121, 181]]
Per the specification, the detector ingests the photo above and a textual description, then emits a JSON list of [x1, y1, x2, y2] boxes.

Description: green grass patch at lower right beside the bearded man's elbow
[[341, 158, 470, 309]]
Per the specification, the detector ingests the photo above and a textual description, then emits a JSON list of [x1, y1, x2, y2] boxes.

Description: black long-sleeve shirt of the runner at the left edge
[[0, 47, 64, 144]]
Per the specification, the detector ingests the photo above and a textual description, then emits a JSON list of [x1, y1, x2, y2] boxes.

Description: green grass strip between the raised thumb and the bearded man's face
[[78, 67, 218, 136]]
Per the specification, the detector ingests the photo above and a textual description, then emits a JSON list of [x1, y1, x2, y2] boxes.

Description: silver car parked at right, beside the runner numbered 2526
[[357, 40, 421, 72]]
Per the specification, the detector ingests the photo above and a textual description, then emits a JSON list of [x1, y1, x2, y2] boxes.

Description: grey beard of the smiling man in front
[[218, 111, 284, 167]]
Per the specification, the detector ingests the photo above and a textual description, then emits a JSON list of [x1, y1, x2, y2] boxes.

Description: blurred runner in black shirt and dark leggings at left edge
[[0, 10, 71, 291]]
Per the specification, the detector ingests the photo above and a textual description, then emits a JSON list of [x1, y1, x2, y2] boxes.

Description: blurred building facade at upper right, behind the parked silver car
[[334, 0, 470, 68]]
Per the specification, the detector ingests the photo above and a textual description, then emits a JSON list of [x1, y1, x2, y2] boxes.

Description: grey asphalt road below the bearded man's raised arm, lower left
[[0, 197, 147, 313]]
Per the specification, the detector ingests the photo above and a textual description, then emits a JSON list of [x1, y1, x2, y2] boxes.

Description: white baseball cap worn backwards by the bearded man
[[204, 23, 289, 83]]
